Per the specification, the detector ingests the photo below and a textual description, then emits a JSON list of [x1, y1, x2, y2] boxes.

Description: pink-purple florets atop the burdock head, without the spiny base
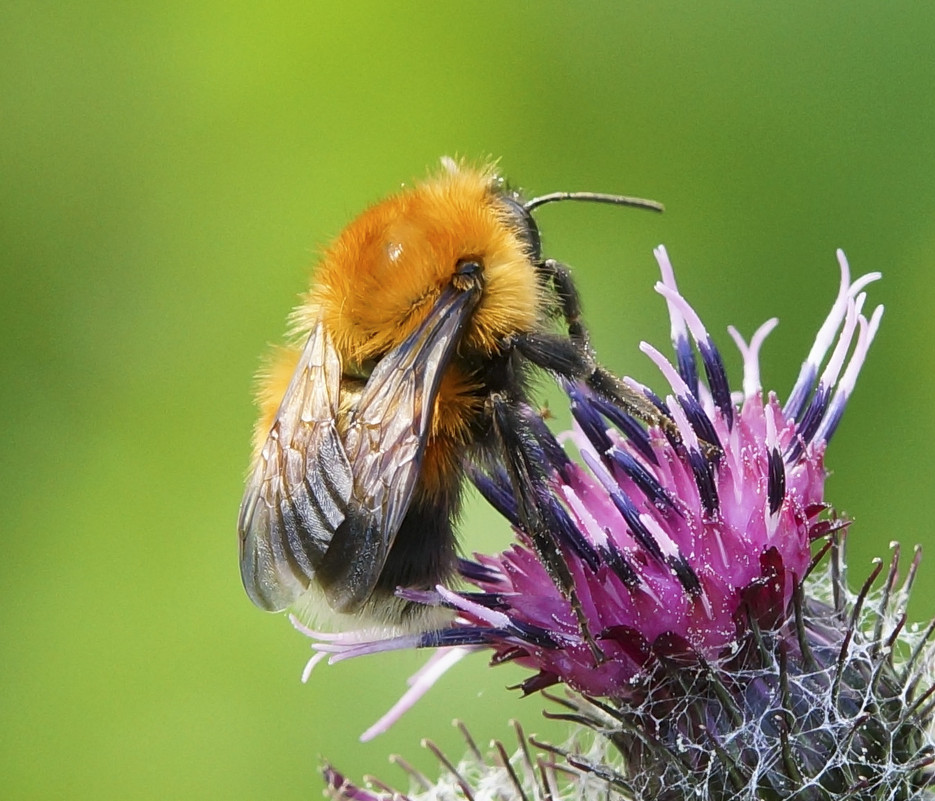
[[307, 247, 883, 698]]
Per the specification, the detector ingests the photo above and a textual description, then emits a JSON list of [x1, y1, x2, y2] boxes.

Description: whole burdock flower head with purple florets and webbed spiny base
[[307, 248, 935, 799]]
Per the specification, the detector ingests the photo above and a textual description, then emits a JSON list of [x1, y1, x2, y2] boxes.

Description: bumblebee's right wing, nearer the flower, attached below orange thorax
[[319, 288, 477, 612]]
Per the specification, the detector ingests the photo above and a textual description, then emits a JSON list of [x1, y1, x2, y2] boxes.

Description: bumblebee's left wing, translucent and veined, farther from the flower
[[238, 322, 354, 612]]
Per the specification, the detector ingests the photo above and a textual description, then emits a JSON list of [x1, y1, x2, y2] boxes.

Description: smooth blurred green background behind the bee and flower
[[0, 0, 935, 800]]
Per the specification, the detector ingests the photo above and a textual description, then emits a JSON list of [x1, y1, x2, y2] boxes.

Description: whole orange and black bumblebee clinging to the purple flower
[[238, 159, 661, 625]]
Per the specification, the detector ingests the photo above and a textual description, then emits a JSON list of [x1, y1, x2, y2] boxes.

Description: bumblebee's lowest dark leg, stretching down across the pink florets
[[489, 393, 605, 664]]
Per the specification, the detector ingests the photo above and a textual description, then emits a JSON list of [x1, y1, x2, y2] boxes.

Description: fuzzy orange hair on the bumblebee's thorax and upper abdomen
[[254, 160, 547, 462]]
